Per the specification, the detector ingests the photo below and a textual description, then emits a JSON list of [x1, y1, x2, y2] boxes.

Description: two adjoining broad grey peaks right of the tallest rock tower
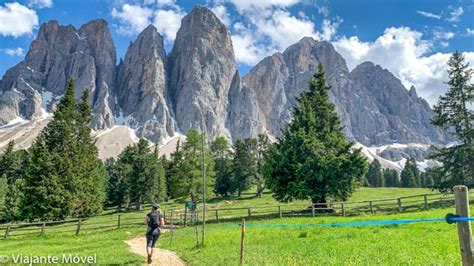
[[243, 37, 448, 146]]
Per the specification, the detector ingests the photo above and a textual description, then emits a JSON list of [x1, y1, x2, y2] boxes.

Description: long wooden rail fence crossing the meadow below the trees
[[0, 191, 460, 239]]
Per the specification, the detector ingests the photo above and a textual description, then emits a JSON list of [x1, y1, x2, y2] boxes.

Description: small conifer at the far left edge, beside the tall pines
[[0, 141, 27, 221]]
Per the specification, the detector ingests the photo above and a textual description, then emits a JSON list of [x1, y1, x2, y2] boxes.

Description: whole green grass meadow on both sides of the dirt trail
[[0, 188, 460, 265]]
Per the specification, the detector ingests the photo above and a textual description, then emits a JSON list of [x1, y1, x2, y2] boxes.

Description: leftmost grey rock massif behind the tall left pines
[[0, 20, 116, 128]]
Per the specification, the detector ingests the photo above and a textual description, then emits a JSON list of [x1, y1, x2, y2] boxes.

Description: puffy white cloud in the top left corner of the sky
[[0, 2, 38, 37]]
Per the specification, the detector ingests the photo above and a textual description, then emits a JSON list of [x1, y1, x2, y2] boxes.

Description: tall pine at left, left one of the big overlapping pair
[[22, 81, 80, 220]]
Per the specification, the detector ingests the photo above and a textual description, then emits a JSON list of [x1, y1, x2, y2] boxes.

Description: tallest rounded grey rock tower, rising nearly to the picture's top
[[169, 6, 237, 138]]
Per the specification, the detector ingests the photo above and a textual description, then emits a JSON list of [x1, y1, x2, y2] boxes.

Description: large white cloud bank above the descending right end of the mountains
[[334, 27, 474, 104]]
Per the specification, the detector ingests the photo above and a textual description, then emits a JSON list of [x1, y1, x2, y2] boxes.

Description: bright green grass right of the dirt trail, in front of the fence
[[160, 209, 460, 265]]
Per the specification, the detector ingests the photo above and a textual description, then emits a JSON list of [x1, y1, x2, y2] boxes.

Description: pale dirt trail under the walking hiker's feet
[[125, 231, 186, 266]]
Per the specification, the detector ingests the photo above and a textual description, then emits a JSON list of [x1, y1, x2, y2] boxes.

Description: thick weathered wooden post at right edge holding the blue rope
[[453, 186, 474, 266]]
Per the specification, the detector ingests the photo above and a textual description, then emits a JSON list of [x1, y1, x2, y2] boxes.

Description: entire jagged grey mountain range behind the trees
[[0, 6, 452, 166]]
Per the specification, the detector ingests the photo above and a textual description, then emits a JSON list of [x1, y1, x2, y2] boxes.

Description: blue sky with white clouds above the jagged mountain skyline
[[0, 0, 474, 103]]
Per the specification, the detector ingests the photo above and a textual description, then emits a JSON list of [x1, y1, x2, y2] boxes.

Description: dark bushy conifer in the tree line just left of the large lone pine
[[232, 138, 257, 197]]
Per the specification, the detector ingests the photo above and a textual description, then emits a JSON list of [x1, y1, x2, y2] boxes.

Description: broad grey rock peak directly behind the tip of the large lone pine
[[243, 37, 351, 140]]
